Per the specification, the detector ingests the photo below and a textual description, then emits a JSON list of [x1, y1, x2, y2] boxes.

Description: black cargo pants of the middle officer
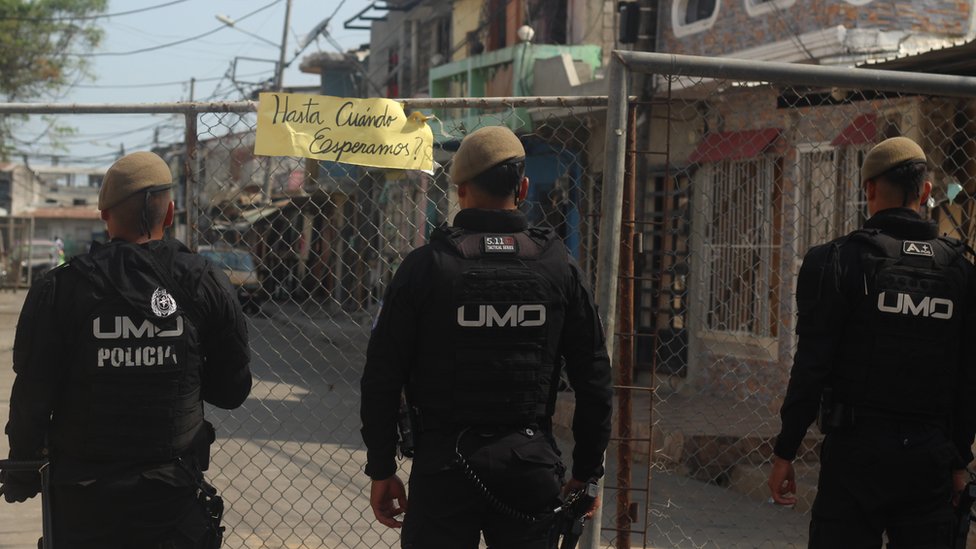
[[402, 428, 565, 549]]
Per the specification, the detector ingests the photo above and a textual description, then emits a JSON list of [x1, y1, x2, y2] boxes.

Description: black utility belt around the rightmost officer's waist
[[817, 388, 946, 435]]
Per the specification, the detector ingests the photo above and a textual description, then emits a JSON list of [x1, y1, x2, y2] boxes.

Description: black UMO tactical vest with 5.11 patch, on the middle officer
[[408, 227, 568, 429]]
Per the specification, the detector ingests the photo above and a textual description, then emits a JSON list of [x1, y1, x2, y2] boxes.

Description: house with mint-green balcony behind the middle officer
[[360, 0, 616, 270]]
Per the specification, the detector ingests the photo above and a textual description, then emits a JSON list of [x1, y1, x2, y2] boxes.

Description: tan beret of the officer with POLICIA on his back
[[98, 151, 173, 210]]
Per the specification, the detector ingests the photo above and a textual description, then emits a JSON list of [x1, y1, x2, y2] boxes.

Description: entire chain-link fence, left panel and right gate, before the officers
[[0, 54, 976, 548]]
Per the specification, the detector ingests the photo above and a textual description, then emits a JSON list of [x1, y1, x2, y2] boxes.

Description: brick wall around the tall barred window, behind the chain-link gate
[[651, 87, 960, 411]]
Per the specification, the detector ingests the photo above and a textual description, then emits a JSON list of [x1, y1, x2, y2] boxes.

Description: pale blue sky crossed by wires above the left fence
[[18, 0, 376, 167]]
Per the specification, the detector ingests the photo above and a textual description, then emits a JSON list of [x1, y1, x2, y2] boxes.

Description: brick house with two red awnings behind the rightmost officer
[[637, 0, 976, 404]]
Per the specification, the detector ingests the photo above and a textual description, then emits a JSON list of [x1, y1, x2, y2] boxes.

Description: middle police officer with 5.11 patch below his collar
[[361, 127, 611, 549]]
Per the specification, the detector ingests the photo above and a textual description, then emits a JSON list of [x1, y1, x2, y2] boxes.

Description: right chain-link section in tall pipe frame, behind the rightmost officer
[[601, 53, 976, 548]]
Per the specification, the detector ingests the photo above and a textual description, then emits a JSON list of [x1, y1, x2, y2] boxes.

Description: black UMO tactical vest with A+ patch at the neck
[[833, 230, 966, 421]]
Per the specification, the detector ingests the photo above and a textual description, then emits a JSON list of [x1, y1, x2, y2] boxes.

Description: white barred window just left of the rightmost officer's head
[[796, 145, 867, 255]]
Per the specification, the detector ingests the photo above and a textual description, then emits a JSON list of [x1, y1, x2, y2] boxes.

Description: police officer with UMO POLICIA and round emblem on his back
[[4, 152, 251, 549]]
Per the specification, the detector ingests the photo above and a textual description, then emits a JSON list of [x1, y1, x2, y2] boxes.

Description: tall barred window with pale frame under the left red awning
[[703, 156, 782, 338]]
